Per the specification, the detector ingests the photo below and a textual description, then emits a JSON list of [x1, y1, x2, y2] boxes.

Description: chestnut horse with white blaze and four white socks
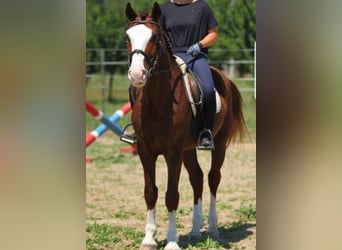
[[126, 3, 245, 249]]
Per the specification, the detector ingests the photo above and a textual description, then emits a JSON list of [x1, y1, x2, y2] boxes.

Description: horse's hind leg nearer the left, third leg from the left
[[183, 149, 203, 239]]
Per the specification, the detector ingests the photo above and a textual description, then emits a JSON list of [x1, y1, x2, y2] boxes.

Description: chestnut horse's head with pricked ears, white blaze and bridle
[[126, 3, 161, 88]]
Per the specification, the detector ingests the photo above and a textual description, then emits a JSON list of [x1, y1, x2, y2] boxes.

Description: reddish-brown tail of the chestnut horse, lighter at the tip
[[227, 81, 248, 147]]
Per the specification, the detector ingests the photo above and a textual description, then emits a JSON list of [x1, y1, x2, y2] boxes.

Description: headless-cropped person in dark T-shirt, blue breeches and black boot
[[160, 0, 218, 149]]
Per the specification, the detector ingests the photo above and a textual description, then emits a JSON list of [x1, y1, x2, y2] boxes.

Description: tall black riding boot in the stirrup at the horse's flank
[[198, 98, 216, 150]]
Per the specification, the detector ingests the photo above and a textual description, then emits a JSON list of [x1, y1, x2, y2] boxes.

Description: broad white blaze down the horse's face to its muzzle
[[126, 24, 152, 87]]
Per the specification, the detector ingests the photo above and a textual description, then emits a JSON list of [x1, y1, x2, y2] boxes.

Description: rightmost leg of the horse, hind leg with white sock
[[207, 136, 226, 238]]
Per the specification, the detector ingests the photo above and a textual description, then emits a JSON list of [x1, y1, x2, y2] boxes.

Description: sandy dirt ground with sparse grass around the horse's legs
[[86, 136, 256, 250]]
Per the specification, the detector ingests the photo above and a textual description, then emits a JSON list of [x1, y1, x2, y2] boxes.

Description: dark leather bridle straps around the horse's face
[[128, 20, 162, 76]]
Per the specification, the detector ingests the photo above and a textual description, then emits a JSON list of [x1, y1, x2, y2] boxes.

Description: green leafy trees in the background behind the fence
[[86, 0, 256, 73]]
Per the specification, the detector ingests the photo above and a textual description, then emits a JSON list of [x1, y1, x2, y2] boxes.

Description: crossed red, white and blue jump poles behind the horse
[[86, 101, 131, 147]]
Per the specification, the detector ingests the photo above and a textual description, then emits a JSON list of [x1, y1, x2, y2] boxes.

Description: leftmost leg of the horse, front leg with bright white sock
[[139, 150, 158, 250]]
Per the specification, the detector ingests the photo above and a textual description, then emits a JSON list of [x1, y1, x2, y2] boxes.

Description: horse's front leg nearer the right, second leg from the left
[[165, 149, 182, 250]]
